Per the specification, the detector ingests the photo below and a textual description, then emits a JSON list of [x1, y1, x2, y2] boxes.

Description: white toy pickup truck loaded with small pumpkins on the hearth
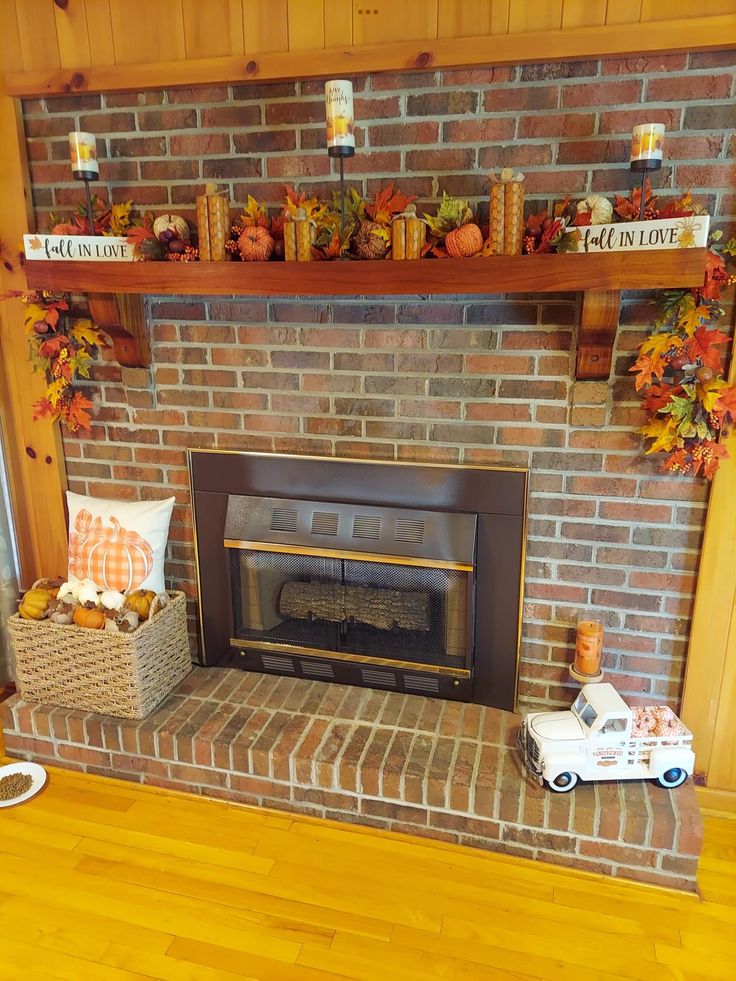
[[519, 683, 695, 793]]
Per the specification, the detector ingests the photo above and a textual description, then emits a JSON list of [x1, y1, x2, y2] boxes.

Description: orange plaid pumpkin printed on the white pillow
[[77, 511, 153, 593]]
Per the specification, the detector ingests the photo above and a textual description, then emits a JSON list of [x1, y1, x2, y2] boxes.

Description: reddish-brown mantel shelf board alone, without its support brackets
[[26, 249, 706, 298]]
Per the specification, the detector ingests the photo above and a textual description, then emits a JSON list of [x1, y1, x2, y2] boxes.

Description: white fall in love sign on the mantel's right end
[[577, 215, 710, 252]]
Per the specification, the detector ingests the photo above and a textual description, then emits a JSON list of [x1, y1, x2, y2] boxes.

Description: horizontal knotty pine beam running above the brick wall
[[5, 14, 734, 96]]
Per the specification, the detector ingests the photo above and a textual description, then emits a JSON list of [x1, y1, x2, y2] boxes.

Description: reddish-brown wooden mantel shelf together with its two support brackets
[[25, 249, 706, 379]]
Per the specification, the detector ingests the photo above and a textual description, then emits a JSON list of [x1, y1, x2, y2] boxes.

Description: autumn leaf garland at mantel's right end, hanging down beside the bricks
[[524, 182, 736, 480]]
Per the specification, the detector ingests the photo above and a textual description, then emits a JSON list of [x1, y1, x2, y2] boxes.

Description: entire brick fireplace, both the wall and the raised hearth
[[5, 51, 736, 888]]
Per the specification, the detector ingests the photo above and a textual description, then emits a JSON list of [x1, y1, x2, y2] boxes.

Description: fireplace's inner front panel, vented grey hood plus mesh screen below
[[224, 496, 476, 678]]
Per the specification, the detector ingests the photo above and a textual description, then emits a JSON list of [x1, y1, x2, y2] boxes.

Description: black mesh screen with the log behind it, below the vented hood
[[229, 548, 472, 670]]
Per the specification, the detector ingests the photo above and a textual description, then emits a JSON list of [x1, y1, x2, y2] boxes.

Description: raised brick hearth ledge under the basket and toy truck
[[0, 668, 702, 891]]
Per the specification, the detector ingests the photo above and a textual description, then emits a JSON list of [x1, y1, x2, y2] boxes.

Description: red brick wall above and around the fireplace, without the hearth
[[25, 52, 736, 703]]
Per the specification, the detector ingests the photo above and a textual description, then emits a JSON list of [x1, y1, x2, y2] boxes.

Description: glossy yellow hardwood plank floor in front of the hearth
[[0, 770, 736, 981]]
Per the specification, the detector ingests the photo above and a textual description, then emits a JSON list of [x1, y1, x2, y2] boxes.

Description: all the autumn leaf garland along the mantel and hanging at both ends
[[14, 181, 736, 480]]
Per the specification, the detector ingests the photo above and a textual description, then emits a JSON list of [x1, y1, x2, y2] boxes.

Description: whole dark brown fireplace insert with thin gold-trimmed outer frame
[[190, 451, 527, 708]]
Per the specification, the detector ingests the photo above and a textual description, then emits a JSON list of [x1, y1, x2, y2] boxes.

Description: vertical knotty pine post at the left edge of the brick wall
[[0, 96, 67, 586]]
